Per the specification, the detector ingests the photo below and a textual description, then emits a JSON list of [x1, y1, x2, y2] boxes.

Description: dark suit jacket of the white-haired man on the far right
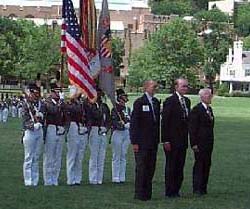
[[189, 103, 214, 150]]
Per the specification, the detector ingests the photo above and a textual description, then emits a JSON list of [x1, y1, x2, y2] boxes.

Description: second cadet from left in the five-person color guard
[[43, 83, 65, 186]]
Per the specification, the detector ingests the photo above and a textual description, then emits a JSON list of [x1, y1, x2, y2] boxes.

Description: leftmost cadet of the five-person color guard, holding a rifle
[[22, 84, 44, 186]]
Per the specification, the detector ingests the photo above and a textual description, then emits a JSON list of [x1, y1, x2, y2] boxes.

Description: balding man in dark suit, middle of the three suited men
[[162, 78, 191, 197]]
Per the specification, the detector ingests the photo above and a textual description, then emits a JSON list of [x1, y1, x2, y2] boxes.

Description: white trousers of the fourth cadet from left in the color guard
[[89, 126, 107, 184]]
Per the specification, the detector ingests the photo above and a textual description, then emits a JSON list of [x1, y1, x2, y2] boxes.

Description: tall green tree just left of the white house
[[195, 8, 234, 90]]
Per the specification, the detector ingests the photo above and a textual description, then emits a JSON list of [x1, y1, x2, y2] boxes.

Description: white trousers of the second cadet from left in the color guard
[[43, 125, 64, 186]]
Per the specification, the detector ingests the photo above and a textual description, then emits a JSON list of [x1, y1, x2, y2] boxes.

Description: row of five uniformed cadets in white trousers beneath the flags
[[22, 84, 130, 186]]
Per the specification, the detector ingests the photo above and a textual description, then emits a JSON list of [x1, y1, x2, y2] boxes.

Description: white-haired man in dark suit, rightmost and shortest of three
[[189, 89, 214, 196]]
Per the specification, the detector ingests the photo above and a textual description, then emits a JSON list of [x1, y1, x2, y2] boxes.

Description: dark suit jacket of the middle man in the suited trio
[[161, 93, 191, 149]]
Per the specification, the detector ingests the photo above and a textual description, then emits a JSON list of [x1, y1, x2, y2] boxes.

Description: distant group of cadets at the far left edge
[[0, 96, 23, 123]]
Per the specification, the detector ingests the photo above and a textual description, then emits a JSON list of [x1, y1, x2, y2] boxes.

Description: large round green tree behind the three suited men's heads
[[129, 18, 203, 90]]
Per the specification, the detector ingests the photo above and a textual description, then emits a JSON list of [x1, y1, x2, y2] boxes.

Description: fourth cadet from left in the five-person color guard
[[88, 88, 110, 184]]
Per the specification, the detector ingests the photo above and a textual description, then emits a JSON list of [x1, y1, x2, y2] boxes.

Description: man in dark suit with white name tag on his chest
[[130, 80, 160, 201]]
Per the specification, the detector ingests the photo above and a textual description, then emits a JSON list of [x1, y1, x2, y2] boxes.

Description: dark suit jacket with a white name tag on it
[[130, 94, 160, 150]]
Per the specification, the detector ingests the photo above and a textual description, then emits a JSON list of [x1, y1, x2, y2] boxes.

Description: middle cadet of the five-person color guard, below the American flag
[[66, 87, 88, 185]]
